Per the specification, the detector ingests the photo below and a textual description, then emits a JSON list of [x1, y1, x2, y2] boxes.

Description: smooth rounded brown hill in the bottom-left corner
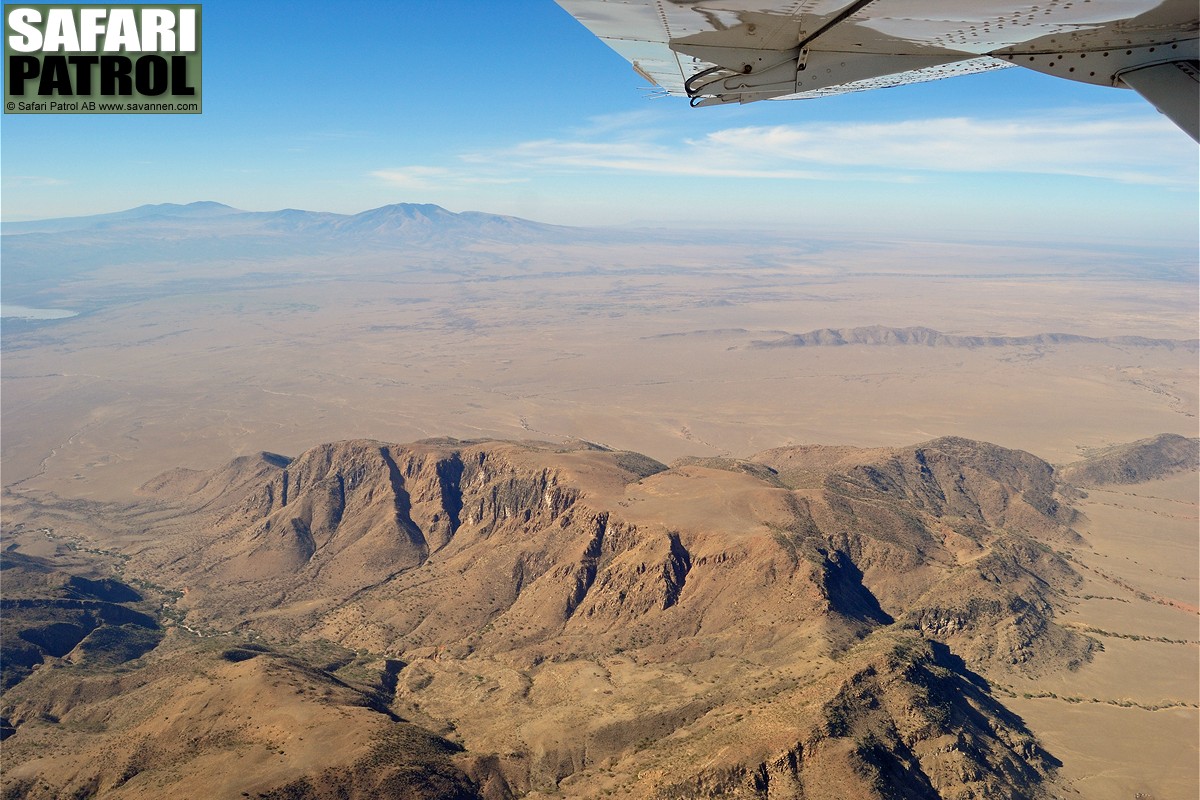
[[4, 634, 478, 800]]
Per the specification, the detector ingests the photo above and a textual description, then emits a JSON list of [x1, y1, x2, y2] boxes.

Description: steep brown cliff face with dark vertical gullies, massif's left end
[[145, 441, 609, 644]]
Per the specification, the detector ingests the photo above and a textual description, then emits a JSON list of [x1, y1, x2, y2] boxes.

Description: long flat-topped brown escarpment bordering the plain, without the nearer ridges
[[136, 439, 1086, 667]]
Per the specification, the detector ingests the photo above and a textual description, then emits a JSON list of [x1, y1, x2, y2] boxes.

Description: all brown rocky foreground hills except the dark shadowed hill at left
[[2, 438, 1113, 799]]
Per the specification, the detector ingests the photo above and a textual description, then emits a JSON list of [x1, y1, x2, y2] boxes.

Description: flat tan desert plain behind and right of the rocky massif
[[2, 203, 1200, 800]]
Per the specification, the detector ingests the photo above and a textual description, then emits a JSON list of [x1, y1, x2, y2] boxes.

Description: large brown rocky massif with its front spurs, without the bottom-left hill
[[96, 438, 1092, 798]]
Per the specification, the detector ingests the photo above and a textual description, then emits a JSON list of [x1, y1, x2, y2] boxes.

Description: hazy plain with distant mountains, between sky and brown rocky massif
[[4, 204, 1198, 497]]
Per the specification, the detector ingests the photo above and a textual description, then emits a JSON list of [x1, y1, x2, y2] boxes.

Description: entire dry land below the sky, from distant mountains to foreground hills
[[0, 204, 1200, 800]]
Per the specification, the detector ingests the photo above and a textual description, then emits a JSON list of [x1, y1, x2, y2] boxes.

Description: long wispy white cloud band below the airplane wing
[[463, 110, 1196, 187]]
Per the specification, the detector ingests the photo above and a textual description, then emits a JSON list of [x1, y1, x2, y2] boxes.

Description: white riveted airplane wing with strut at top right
[[557, 0, 1200, 140]]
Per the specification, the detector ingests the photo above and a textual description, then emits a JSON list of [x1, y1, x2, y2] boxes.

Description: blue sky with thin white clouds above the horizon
[[0, 0, 1200, 245]]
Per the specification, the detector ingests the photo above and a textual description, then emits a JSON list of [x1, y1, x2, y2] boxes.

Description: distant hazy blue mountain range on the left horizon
[[0, 201, 590, 307]]
